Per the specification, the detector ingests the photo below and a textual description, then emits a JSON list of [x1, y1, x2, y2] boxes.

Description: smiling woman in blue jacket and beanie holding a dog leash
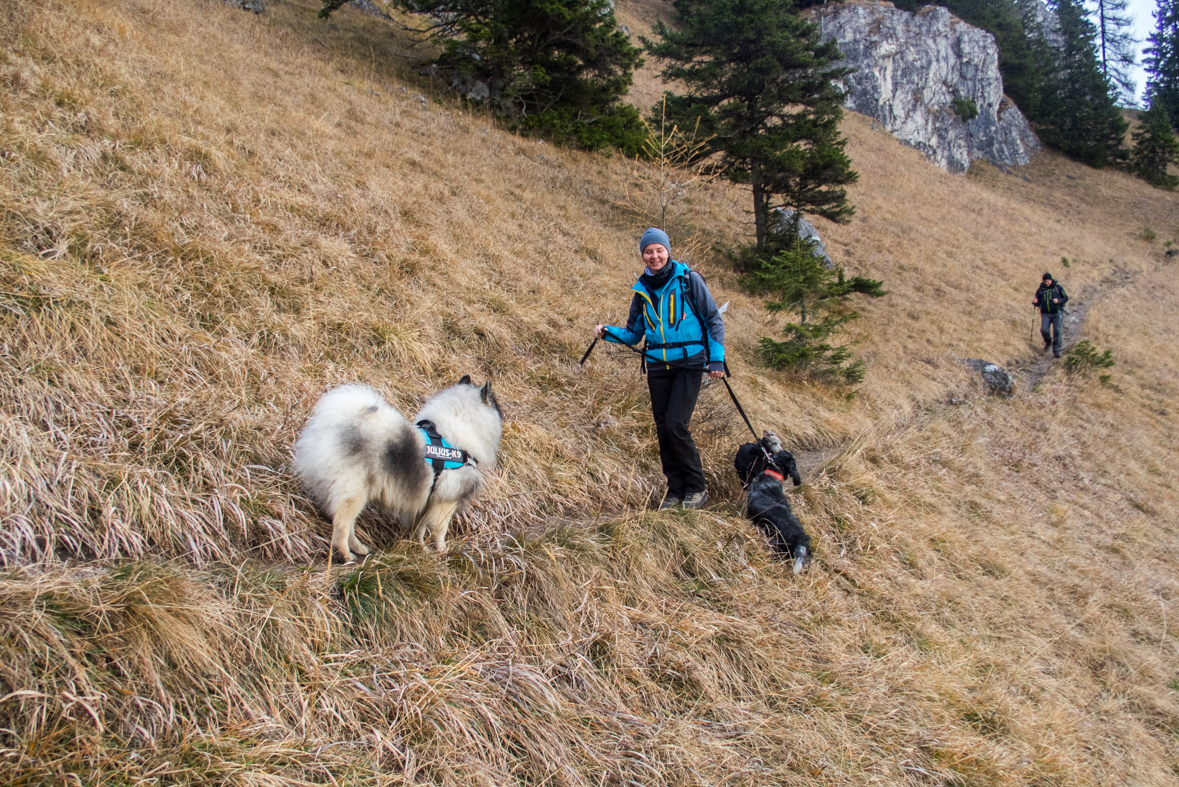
[[593, 227, 725, 508]]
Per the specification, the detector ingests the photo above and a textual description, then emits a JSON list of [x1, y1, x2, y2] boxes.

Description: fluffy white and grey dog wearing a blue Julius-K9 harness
[[295, 375, 503, 562]]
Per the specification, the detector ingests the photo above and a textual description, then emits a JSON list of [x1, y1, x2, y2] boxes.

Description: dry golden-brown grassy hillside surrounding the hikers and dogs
[[0, 0, 1179, 785]]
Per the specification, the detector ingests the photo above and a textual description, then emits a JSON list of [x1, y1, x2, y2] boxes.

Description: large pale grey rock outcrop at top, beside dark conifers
[[816, 2, 1040, 172]]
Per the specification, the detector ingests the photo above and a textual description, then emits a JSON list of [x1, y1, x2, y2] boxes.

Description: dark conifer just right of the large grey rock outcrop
[[1035, 0, 1126, 167]]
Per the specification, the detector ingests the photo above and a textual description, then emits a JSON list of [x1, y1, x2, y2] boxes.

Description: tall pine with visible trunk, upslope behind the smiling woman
[[644, 0, 857, 250]]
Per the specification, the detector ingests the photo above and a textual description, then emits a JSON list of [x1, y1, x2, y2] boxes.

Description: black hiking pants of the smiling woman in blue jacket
[[647, 366, 704, 500]]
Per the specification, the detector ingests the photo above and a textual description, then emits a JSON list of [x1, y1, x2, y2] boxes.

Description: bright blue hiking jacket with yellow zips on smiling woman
[[604, 260, 725, 371]]
